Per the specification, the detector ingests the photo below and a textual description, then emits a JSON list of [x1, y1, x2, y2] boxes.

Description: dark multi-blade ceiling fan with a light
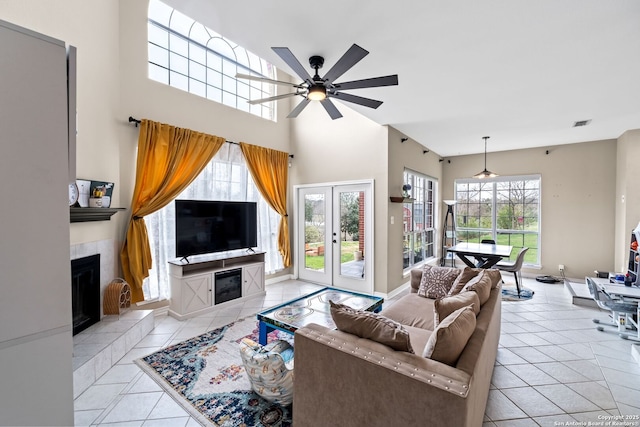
[[236, 44, 398, 120]]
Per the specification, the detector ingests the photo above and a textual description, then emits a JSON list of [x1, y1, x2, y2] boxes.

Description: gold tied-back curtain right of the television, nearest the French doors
[[240, 142, 291, 268]]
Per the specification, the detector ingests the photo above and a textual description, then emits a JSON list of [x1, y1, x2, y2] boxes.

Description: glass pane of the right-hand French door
[[337, 191, 365, 278]]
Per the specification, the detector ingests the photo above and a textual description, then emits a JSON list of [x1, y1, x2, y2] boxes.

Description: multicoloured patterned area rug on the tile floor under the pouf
[[135, 316, 293, 427]]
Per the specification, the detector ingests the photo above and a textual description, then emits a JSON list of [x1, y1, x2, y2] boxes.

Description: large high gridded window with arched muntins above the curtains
[[148, 0, 276, 121]]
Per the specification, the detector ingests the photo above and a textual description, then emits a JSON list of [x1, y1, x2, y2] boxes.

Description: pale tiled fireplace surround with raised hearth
[[70, 239, 154, 398]]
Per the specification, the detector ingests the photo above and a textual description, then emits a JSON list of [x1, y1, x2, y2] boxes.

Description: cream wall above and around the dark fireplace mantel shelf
[[0, 0, 124, 247]]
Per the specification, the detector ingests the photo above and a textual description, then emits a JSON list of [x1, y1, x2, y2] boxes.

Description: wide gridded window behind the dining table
[[455, 175, 540, 266]]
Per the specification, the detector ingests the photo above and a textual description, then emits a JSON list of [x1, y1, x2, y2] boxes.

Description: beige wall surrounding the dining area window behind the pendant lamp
[[443, 140, 616, 278]]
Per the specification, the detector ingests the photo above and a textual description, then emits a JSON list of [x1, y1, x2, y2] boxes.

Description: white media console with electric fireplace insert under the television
[[169, 250, 265, 319]]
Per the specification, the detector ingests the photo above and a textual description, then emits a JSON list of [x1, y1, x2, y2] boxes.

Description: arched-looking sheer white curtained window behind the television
[[143, 144, 283, 300]]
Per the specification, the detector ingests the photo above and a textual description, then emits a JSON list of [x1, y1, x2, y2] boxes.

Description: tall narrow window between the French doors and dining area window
[[402, 170, 436, 269]]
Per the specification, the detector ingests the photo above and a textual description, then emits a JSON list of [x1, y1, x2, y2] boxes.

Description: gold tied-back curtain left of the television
[[120, 120, 225, 302]]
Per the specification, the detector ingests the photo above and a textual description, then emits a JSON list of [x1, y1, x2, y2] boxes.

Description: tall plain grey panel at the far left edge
[[0, 19, 74, 425]]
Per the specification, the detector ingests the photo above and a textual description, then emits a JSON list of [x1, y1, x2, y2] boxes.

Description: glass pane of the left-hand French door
[[304, 193, 326, 271]]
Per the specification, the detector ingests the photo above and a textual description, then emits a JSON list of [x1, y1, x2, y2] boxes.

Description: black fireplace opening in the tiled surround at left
[[71, 254, 100, 335]]
